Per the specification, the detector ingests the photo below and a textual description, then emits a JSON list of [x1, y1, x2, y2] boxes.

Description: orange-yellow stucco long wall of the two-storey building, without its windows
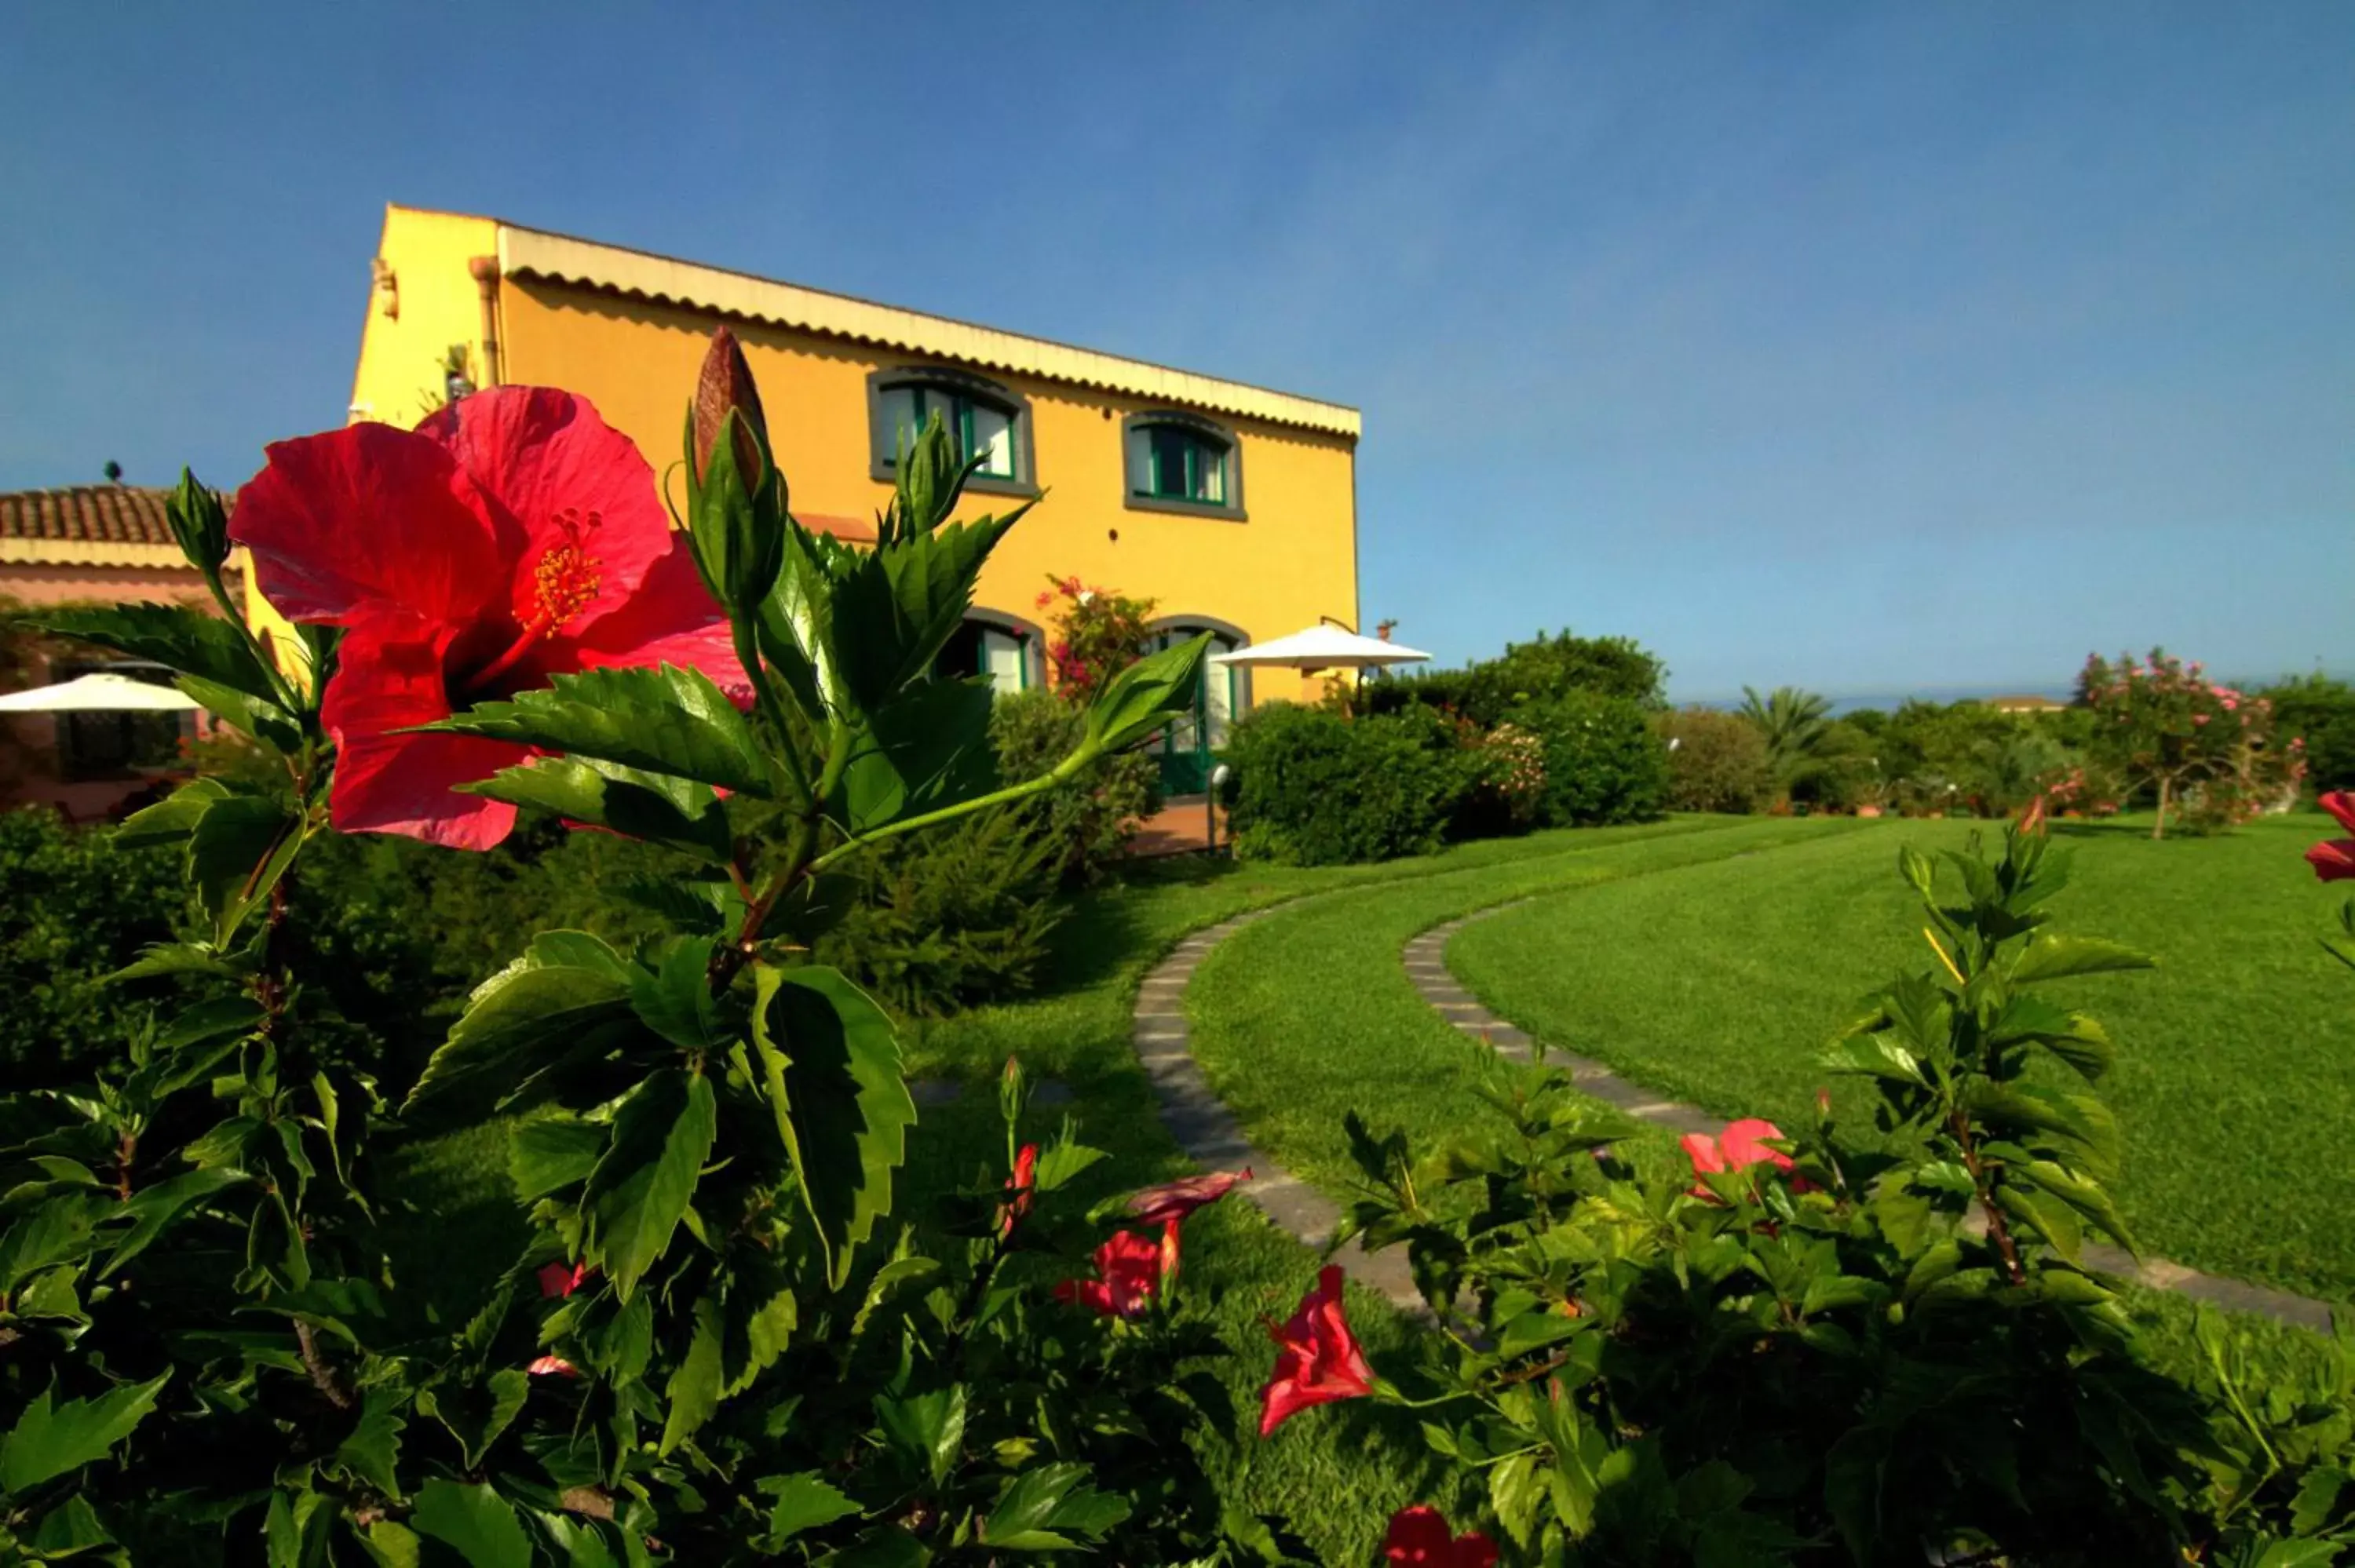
[[499, 278, 1356, 702]]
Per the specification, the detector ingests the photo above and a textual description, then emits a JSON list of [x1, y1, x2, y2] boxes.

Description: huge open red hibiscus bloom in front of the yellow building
[[228, 386, 744, 850]]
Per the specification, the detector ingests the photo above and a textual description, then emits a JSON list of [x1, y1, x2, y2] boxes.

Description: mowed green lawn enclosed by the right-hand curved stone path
[[1448, 815, 2355, 1297]]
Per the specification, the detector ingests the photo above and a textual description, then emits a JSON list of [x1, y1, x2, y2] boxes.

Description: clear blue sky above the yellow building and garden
[[0, 0, 2355, 697]]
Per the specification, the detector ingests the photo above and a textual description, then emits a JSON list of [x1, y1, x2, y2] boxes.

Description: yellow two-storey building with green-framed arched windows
[[304, 207, 1359, 791]]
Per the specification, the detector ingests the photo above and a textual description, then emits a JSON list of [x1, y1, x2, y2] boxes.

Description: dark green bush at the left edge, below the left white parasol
[[0, 808, 186, 1088]]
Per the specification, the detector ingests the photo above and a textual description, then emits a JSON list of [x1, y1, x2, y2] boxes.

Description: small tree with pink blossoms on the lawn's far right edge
[[2077, 647, 2303, 838]]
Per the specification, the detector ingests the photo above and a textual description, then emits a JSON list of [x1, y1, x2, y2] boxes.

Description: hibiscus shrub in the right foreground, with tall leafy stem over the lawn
[[1267, 812, 2355, 1566]]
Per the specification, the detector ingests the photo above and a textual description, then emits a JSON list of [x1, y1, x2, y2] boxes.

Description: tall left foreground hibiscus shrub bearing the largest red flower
[[0, 332, 1328, 1568]]
